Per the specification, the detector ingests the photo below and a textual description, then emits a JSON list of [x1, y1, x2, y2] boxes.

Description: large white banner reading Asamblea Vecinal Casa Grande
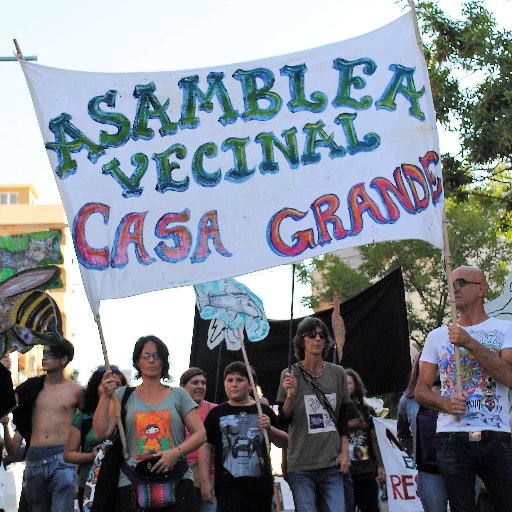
[[22, 13, 444, 312]]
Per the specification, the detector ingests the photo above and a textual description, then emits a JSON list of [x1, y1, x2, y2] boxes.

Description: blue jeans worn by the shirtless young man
[[25, 446, 77, 512]]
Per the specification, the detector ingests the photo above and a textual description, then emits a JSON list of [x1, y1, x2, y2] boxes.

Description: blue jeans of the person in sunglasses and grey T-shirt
[[288, 466, 345, 512]]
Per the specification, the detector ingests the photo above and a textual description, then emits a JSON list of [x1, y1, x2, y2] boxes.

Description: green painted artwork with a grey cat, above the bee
[[0, 230, 64, 281]]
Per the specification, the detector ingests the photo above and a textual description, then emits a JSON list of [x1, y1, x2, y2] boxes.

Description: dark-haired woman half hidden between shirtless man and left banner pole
[[64, 365, 126, 510]]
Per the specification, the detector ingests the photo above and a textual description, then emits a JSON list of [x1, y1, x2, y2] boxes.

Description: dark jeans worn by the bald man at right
[[436, 432, 512, 512]]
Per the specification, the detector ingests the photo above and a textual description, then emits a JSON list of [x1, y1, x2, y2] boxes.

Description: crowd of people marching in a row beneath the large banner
[[0, 267, 512, 512]]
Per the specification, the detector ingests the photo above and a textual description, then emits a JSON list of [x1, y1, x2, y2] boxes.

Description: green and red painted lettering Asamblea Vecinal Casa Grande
[[45, 57, 442, 270]]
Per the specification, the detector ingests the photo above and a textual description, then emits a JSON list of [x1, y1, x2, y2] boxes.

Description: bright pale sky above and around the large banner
[[0, 0, 512, 381]]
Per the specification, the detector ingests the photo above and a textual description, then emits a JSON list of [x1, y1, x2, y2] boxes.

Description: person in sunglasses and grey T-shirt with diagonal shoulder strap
[[277, 317, 350, 512]]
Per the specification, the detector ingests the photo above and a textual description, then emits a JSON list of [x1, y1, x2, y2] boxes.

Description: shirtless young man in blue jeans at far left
[[1, 339, 83, 512]]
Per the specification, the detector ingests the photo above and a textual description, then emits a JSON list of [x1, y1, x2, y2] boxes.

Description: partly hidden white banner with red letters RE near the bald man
[[373, 418, 423, 512]]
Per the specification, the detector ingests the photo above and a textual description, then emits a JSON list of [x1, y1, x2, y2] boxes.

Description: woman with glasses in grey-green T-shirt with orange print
[[93, 335, 206, 512]]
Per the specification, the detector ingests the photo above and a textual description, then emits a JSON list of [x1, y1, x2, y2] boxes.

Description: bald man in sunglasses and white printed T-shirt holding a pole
[[415, 266, 512, 512]]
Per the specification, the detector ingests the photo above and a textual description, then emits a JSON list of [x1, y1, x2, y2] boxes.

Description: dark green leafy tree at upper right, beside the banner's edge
[[412, 0, 512, 206]]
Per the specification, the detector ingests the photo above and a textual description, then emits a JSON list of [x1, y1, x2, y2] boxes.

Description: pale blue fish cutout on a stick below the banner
[[194, 277, 270, 341]]
